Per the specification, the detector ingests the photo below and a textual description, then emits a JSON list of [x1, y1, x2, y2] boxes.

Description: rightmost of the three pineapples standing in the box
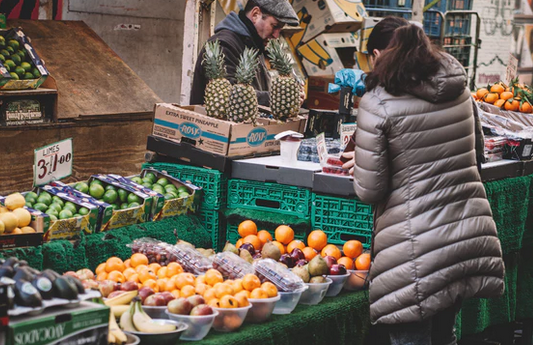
[[267, 39, 300, 120]]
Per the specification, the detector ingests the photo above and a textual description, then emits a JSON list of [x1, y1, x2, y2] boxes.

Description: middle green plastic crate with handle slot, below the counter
[[228, 179, 311, 218]]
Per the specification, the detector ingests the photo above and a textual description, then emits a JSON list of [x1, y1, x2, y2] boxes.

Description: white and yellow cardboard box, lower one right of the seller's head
[[298, 32, 357, 77]]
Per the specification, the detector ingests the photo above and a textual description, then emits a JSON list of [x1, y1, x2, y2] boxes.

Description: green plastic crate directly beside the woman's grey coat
[[311, 193, 374, 248]]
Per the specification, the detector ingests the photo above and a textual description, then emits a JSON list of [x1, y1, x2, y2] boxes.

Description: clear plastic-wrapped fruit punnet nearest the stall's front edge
[[254, 259, 305, 291]]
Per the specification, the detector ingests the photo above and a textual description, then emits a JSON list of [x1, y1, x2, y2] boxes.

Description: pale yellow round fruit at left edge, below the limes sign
[[0, 193, 35, 235]]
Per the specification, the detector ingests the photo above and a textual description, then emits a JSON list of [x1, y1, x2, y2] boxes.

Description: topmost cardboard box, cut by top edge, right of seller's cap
[[291, 0, 367, 47]]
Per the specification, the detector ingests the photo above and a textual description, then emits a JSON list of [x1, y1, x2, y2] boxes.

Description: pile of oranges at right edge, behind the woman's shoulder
[[472, 82, 533, 113]]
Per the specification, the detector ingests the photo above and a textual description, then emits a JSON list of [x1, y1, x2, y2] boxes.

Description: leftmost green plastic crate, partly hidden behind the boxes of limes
[[143, 163, 228, 210]]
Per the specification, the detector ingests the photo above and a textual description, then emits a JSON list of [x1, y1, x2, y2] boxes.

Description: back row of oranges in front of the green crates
[[235, 220, 370, 270]]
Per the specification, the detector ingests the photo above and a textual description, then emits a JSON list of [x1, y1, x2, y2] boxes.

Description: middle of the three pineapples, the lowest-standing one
[[228, 48, 259, 123]]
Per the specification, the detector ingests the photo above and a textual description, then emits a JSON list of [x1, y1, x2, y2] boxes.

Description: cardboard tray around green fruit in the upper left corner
[[0, 28, 50, 90]]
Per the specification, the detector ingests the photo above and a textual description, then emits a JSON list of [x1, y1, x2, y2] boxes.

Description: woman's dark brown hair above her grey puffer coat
[[366, 24, 441, 96]]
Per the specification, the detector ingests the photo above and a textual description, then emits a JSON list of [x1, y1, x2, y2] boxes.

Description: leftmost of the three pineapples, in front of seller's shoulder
[[202, 40, 231, 120]]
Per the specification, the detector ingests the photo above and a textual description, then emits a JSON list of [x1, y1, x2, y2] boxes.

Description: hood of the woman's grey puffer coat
[[408, 53, 467, 103]]
